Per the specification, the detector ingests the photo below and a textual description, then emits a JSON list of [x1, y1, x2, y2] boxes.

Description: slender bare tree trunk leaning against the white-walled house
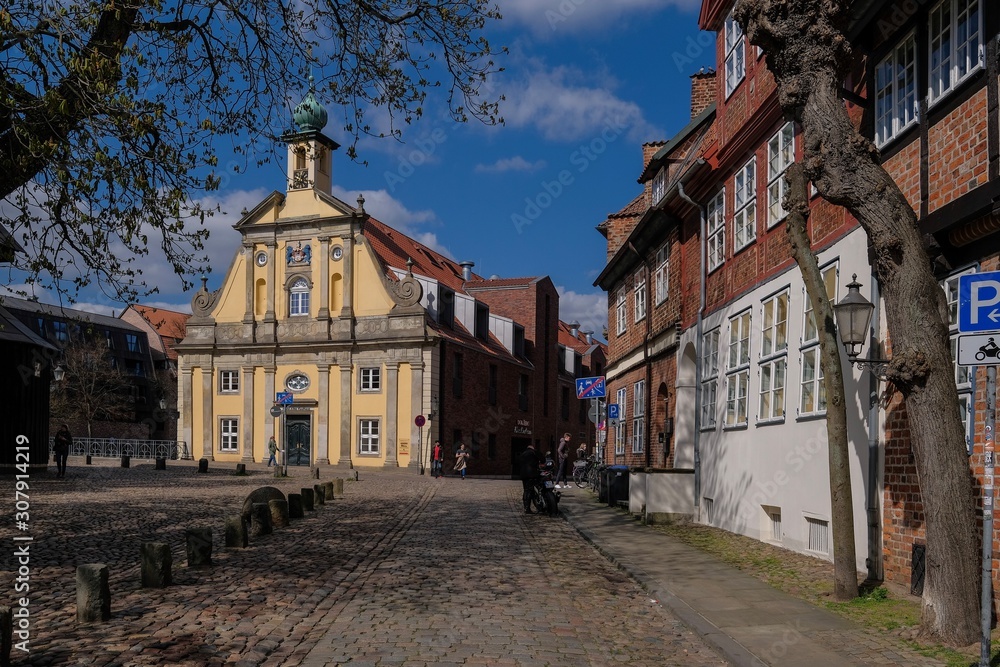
[[785, 163, 858, 600]]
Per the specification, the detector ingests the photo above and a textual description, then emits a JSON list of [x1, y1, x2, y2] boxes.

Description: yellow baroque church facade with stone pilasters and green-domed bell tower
[[177, 92, 437, 467]]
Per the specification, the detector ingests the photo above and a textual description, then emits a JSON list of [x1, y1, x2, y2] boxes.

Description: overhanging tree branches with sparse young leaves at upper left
[[0, 0, 504, 301]]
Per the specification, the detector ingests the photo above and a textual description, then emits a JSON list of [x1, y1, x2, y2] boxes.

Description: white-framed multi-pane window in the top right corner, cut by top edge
[[927, 0, 985, 104]]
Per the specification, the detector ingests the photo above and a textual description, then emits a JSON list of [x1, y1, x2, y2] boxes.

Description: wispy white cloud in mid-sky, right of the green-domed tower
[[502, 62, 665, 142]]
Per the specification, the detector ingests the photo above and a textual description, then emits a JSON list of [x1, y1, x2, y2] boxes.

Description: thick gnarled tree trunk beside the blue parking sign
[[735, 0, 981, 646]]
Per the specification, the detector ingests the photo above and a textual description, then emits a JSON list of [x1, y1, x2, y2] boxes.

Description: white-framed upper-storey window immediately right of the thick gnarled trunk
[[875, 33, 917, 146]]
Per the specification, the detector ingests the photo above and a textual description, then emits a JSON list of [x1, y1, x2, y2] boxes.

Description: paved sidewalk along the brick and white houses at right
[[559, 489, 944, 667]]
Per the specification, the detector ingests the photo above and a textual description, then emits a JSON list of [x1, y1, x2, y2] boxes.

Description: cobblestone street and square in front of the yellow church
[[0, 459, 724, 667]]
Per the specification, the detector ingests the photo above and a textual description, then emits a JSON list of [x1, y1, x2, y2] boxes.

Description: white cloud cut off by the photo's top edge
[[497, 0, 701, 37]]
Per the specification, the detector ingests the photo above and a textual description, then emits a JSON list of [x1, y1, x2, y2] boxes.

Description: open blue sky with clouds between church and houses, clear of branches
[[3, 0, 714, 336]]
